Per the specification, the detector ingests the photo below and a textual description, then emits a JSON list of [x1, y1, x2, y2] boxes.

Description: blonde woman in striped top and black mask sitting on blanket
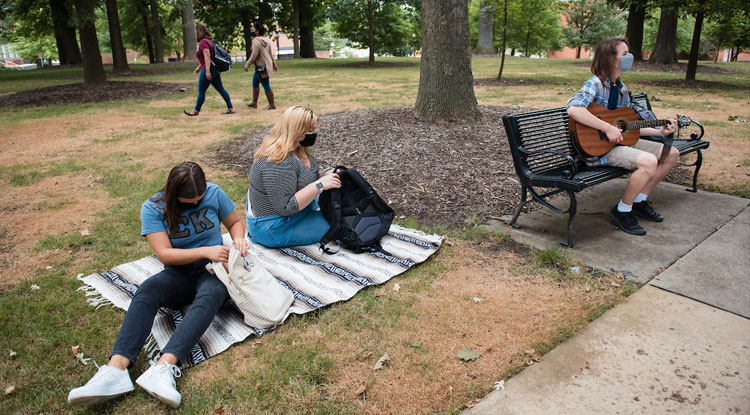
[[246, 106, 341, 248]]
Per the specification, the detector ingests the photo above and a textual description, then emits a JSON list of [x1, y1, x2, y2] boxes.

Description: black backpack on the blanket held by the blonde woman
[[318, 167, 394, 254]]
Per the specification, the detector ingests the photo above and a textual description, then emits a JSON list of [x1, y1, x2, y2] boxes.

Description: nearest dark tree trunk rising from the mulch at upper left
[[75, 0, 107, 85]]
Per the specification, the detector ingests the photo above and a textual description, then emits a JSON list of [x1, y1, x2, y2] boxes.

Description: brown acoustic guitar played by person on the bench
[[568, 102, 691, 157]]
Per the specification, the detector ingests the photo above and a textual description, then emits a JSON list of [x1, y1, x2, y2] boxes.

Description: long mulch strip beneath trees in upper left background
[[0, 81, 194, 107]]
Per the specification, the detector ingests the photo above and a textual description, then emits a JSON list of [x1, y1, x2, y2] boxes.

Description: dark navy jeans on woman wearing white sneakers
[[110, 259, 229, 367]]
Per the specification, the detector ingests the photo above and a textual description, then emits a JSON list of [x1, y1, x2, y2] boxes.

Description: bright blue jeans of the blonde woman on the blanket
[[247, 199, 330, 248]]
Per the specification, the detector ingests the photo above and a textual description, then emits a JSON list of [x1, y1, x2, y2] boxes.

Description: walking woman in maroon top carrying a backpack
[[184, 23, 234, 117]]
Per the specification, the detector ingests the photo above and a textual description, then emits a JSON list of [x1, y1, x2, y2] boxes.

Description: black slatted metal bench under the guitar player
[[503, 94, 709, 248]]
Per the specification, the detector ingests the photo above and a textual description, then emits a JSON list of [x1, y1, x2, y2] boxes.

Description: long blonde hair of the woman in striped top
[[253, 105, 318, 163]]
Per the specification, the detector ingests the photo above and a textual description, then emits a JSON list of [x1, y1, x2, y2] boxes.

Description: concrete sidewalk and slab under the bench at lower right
[[472, 185, 750, 415]]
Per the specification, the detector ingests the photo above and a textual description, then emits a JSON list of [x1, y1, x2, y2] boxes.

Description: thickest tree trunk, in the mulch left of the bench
[[414, 0, 479, 121]]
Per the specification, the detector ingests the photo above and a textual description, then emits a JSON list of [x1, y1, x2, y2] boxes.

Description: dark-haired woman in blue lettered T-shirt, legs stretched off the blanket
[[68, 162, 249, 408]]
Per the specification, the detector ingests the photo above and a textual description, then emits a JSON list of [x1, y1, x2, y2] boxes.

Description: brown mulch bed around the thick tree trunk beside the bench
[[217, 106, 520, 226]]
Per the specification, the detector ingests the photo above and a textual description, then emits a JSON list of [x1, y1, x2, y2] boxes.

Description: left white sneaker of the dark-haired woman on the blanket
[[68, 365, 135, 405]]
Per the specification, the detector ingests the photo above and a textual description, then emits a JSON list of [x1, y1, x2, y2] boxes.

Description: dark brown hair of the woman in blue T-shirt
[[151, 161, 206, 232]]
